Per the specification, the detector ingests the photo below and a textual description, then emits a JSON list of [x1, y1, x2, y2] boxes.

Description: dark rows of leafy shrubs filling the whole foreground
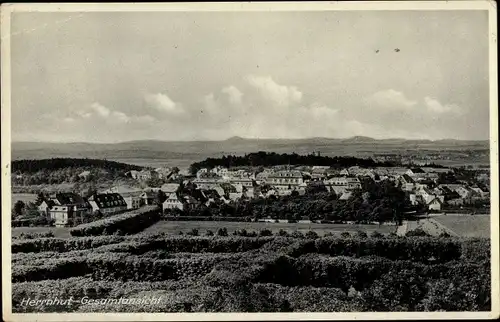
[[12, 233, 491, 312]]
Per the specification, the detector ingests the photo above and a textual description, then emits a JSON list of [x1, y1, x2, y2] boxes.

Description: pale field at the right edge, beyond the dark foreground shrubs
[[432, 215, 491, 238]]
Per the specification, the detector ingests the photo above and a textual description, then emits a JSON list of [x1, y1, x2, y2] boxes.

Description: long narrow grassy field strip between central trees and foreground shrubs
[[139, 221, 396, 236]]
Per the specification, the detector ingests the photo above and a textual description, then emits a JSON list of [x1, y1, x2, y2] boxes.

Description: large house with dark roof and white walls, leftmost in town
[[44, 192, 90, 227]]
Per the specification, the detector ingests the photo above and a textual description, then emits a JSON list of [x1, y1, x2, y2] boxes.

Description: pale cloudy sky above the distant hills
[[11, 10, 489, 142]]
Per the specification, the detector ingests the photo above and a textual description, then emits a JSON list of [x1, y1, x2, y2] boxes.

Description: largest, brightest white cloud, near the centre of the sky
[[246, 75, 302, 106]]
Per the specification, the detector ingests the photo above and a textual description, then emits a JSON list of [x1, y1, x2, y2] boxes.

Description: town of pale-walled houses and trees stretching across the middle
[[13, 153, 489, 230]]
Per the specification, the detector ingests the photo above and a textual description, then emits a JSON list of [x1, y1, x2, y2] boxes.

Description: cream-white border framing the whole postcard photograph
[[1, 0, 500, 321]]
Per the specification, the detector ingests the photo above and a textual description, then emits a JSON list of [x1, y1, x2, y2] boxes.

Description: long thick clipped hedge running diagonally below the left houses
[[70, 206, 161, 237]]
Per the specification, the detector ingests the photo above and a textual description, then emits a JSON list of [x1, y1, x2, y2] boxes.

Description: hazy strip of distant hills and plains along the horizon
[[12, 136, 489, 168]]
